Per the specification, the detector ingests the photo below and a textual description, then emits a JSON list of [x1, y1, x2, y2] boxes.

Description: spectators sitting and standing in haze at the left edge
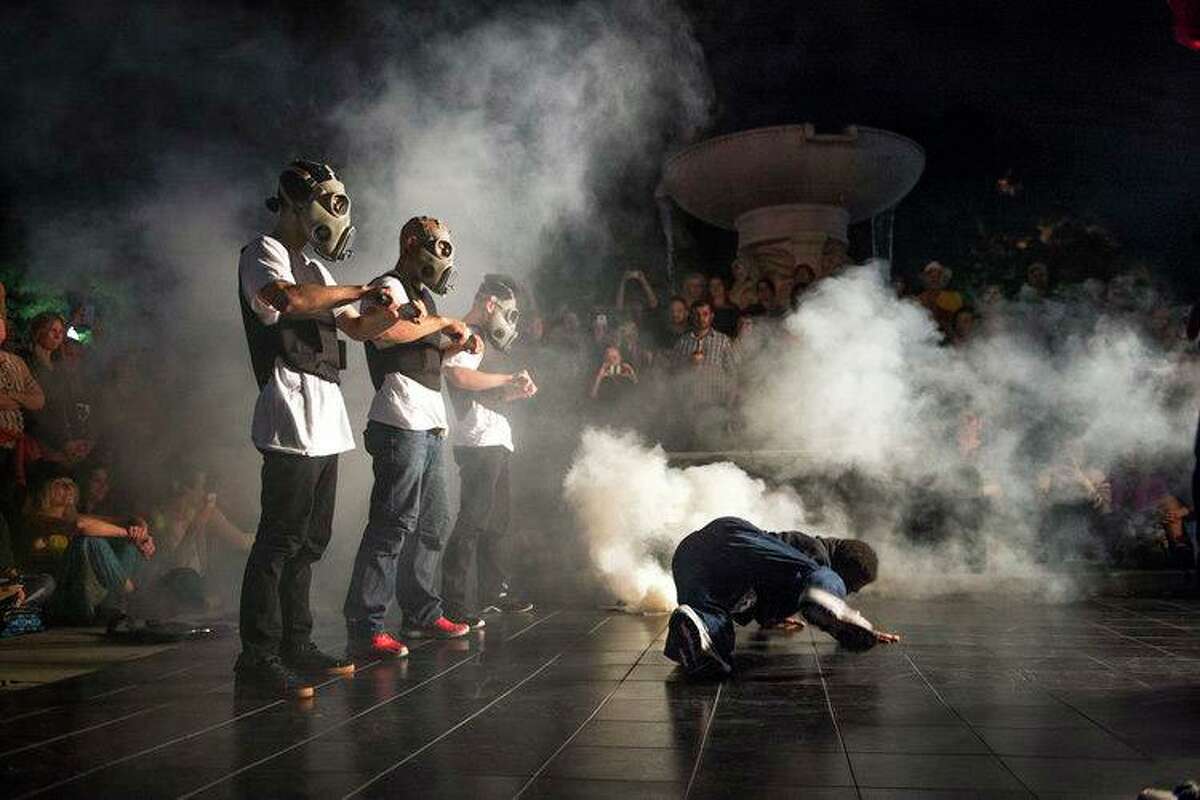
[[0, 284, 251, 636]]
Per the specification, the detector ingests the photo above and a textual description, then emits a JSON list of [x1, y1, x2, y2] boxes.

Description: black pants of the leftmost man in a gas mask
[[241, 451, 337, 658]]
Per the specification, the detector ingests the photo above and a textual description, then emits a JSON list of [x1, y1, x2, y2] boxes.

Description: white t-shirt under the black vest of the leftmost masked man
[[238, 236, 354, 457]]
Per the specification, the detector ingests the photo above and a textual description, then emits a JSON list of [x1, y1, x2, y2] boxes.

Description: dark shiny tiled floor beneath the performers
[[0, 599, 1200, 800]]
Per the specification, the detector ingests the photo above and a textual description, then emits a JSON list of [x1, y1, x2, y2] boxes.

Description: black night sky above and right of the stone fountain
[[689, 0, 1200, 282]]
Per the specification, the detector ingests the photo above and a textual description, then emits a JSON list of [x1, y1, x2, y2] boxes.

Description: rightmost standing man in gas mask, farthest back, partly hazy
[[442, 275, 538, 628]]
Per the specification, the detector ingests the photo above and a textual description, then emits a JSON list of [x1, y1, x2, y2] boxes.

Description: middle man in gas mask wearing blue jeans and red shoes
[[343, 217, 482, 657]]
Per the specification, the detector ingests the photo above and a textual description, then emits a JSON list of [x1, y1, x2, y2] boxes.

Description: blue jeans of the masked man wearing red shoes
[[343, 421, 450, 639]]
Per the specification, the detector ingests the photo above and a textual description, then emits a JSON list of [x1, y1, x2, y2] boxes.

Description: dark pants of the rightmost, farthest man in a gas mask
[[442, 446, 512, 614]]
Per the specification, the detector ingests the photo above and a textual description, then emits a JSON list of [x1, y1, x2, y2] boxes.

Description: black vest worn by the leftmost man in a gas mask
[[238, 256, 346, 389]]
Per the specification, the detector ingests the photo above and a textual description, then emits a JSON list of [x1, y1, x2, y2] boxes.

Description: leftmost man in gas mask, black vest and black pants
[[235, 161, 400, 697]]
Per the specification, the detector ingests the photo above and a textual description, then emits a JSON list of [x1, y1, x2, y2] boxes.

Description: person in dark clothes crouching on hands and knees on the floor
[[665, 517, 900, 675]]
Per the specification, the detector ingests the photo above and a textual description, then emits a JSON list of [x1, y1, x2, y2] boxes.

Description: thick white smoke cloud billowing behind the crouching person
[[565, 263, 1194, 608]]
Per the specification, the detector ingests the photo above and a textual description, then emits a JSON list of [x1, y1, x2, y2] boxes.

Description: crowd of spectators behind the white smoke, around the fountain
[[520, 209, 1200, 575]]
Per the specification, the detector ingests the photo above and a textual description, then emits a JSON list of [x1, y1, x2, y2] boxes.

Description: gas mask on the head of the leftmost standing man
[[266, 161, 354, 261]]
